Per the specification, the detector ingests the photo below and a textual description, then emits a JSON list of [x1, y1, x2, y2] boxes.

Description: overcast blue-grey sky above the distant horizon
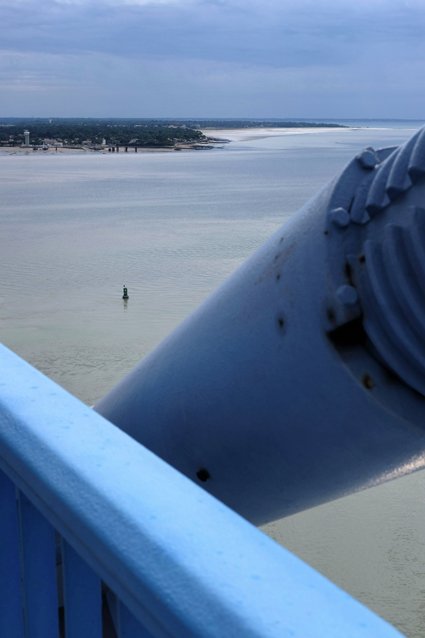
[[0, 0, 425, 120]]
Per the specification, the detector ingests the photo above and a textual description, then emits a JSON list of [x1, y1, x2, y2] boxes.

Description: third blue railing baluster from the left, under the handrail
[[62, 540, 102, 638]]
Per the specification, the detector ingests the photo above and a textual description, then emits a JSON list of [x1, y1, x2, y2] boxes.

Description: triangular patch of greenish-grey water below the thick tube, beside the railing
[[264, 472, 425, 638]]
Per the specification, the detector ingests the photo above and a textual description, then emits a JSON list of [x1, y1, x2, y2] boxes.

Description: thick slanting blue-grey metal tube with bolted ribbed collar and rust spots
[[96, 124, 425, 523]]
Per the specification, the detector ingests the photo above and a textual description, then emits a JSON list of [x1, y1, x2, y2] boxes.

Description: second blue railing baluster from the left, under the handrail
[[19, 493, 59, 638]]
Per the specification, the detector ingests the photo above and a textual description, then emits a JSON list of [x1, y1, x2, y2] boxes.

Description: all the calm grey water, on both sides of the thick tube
[[0, 123, 425, 637]]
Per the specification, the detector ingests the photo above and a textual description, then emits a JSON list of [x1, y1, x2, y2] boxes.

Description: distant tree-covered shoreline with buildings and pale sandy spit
[[0, 118, 345, 155]]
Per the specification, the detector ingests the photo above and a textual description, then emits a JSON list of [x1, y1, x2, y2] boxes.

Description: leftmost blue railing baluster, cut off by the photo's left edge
[[0, 472, 24, 638]]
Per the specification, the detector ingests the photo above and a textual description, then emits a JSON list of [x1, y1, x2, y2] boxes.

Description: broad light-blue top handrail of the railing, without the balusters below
[[0, 348, 400, 638]]
